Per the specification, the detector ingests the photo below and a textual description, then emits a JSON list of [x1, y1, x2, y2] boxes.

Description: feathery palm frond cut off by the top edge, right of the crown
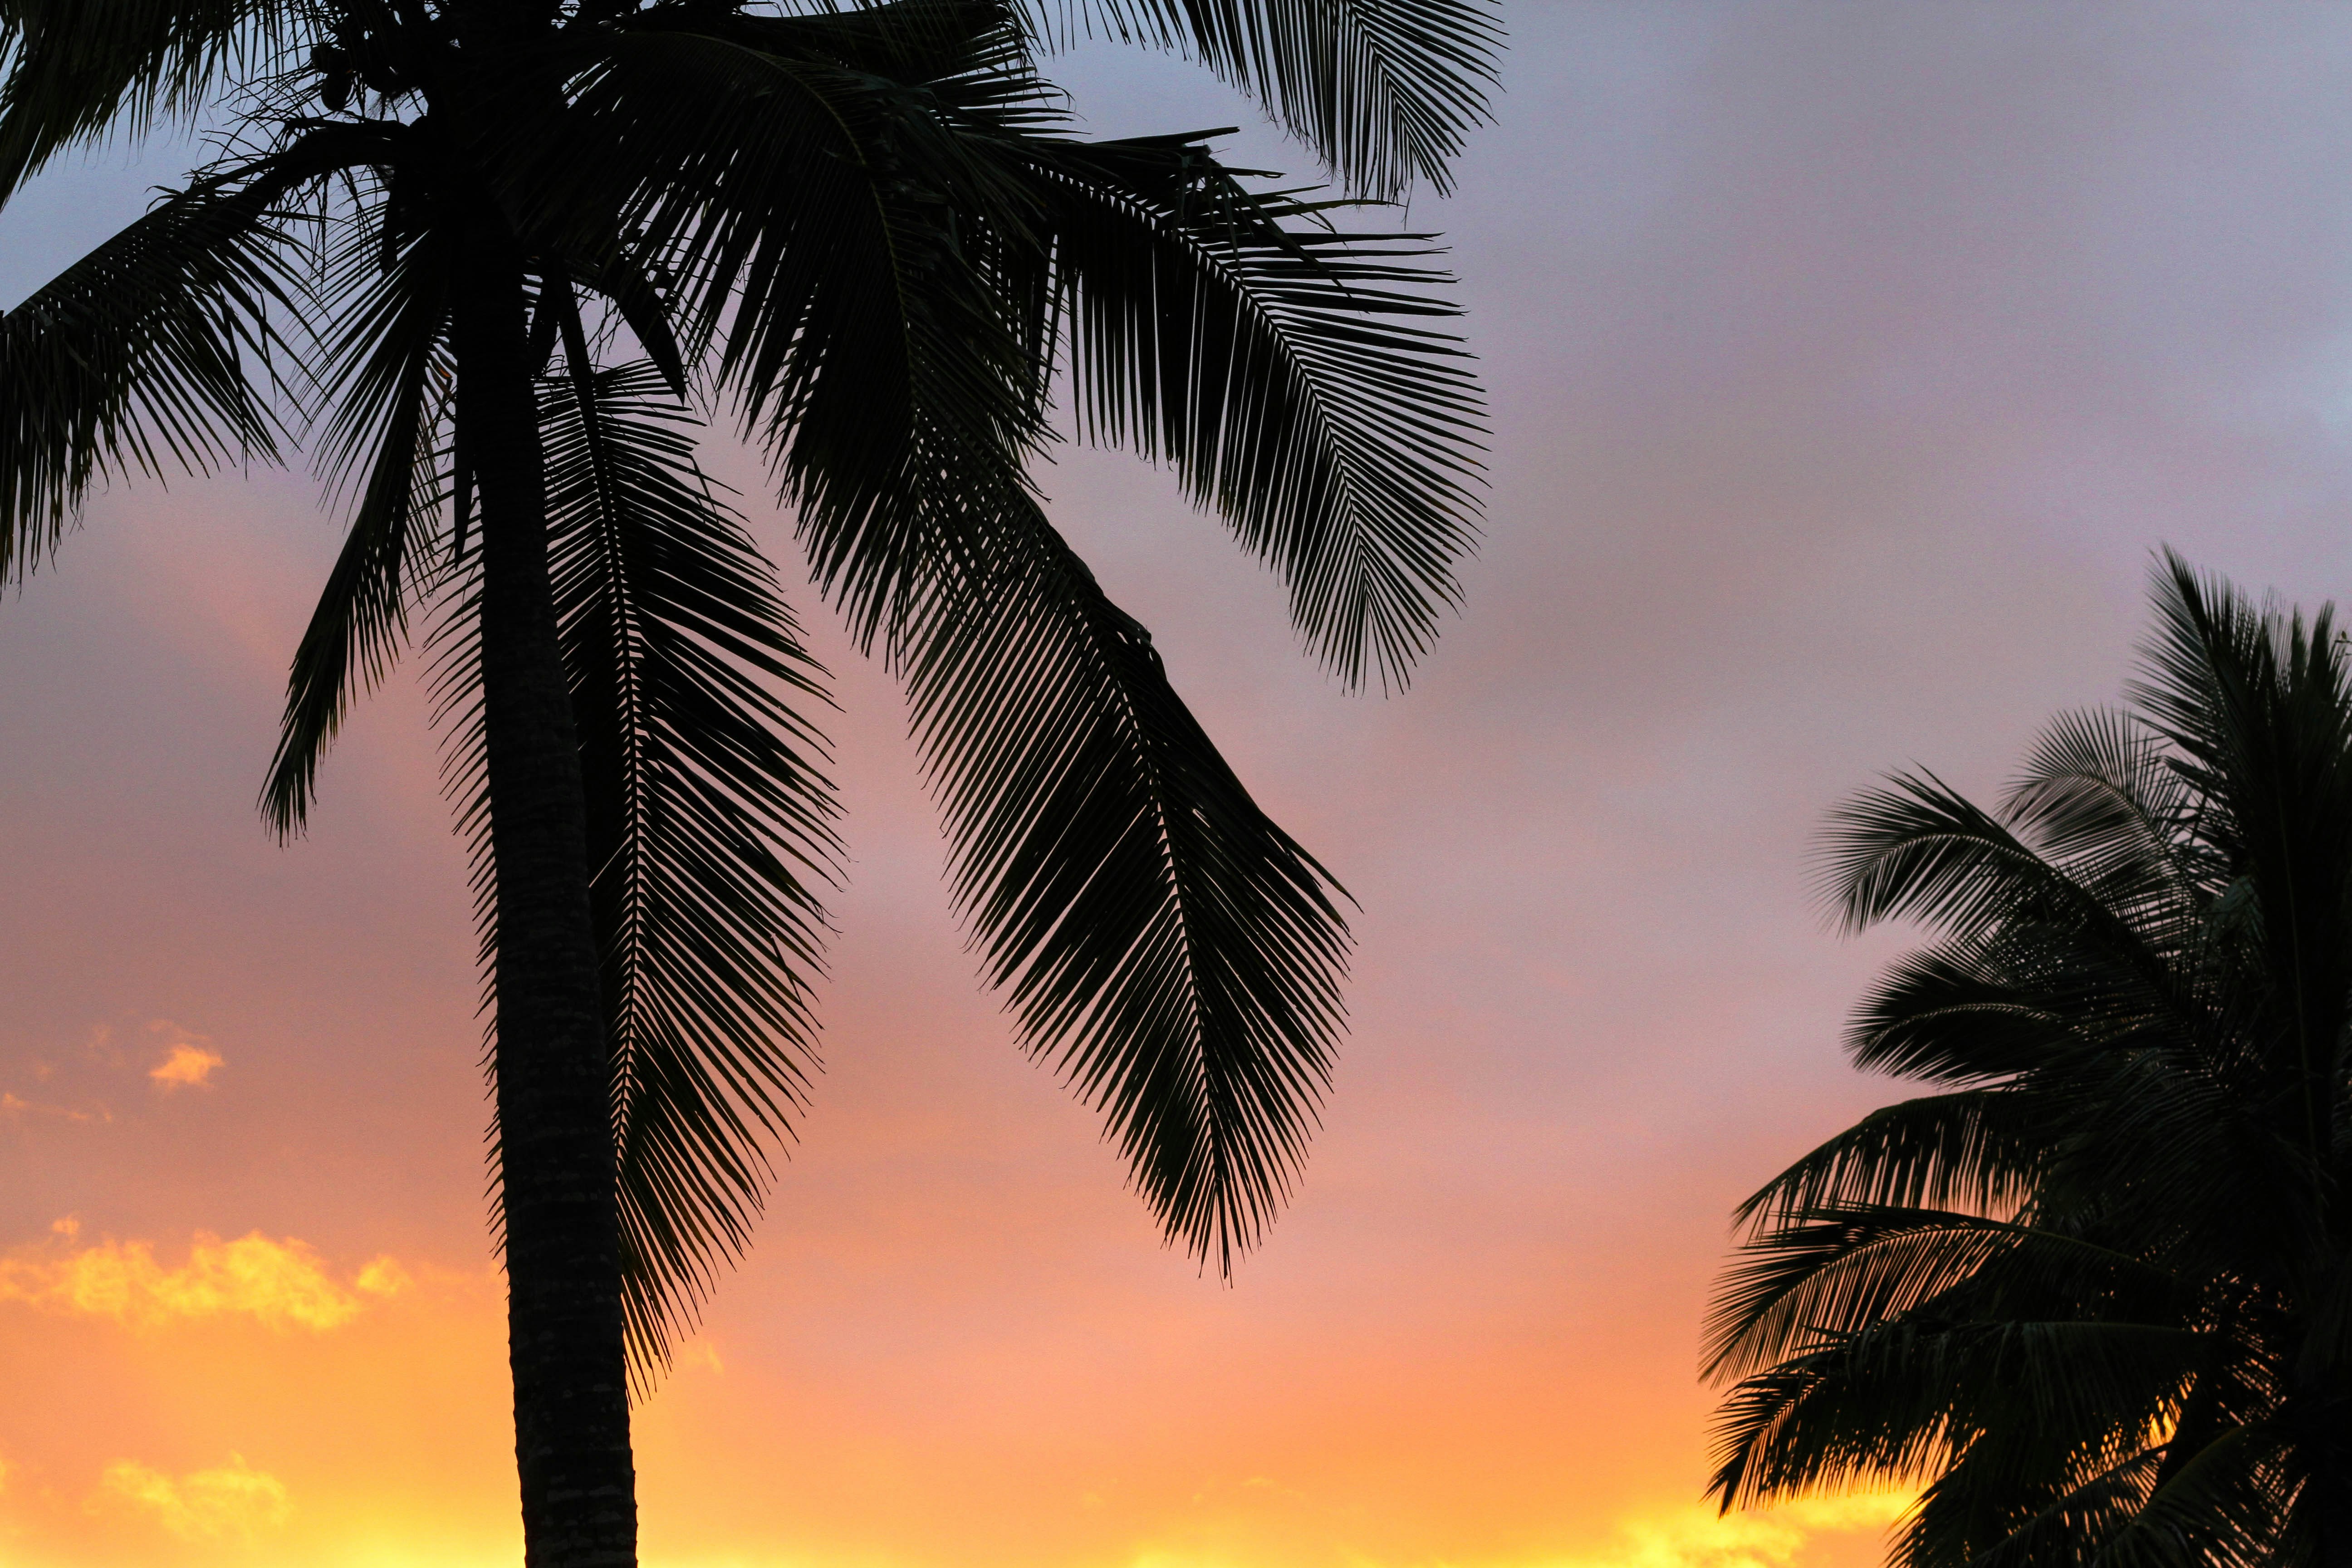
[[1025, 0, 1503, 200]]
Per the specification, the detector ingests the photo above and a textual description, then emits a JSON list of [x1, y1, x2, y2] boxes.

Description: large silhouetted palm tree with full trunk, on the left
[[0, 0, 1496, 1568]]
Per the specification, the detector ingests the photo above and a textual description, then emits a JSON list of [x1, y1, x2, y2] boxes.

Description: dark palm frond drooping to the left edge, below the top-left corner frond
[[0, 167, 299, 583]]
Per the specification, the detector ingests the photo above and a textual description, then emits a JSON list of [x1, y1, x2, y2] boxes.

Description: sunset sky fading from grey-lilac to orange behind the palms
[[0, 0, 2352, 1568]]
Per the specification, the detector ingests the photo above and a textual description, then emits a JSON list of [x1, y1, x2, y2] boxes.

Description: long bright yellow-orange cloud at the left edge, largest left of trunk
[[0, 1222, 409, 1331]]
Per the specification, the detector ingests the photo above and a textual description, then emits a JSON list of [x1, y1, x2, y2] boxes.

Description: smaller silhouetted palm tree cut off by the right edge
[[1708, 553, 2352, 1568]]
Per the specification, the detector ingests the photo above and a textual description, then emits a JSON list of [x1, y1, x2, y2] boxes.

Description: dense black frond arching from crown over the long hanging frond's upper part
[[513, 30, 1042, 644]]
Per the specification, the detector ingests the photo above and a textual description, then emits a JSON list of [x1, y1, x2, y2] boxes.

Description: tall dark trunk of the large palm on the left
[[451, 219, 637, 1568]]
